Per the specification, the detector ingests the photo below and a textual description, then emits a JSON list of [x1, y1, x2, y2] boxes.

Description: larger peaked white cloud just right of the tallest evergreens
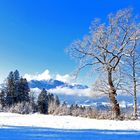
[[24, 70, 51, 81]]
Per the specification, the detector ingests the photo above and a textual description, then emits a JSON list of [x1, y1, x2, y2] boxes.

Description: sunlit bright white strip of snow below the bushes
[[0, 113, 140, 131]]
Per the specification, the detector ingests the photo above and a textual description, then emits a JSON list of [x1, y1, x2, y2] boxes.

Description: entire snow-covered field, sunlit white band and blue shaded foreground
[[0, 113, 140, 140]]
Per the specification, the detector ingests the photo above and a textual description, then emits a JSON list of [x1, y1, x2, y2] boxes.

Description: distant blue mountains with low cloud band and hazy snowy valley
[[29, 79, 140, 110]]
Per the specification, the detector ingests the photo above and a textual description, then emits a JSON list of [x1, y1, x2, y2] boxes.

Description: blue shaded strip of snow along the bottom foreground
[[0, 126, 140, 140]]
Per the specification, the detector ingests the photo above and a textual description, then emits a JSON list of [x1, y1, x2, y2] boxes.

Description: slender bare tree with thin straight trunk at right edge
[[123, 41, 140, 119]]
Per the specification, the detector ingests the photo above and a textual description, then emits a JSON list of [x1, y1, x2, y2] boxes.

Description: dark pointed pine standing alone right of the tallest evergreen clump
[[37, 89, 48, 114]]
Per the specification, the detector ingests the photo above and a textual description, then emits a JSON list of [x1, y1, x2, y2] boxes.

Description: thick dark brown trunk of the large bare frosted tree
[[108, 70, 120, 118]]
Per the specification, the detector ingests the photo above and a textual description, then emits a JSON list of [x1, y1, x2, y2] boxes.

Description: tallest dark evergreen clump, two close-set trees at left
[[5, 70, 30, 105]]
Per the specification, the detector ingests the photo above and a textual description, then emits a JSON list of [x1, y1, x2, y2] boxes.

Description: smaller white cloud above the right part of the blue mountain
[[55, 74, 73, 83]]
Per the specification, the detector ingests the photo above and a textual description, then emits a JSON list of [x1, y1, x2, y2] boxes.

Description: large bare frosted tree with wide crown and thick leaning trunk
[[68, 9, 140, 118]]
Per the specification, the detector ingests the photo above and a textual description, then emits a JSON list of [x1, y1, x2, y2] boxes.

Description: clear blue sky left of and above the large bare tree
[[0, 0, 140, 83]]
